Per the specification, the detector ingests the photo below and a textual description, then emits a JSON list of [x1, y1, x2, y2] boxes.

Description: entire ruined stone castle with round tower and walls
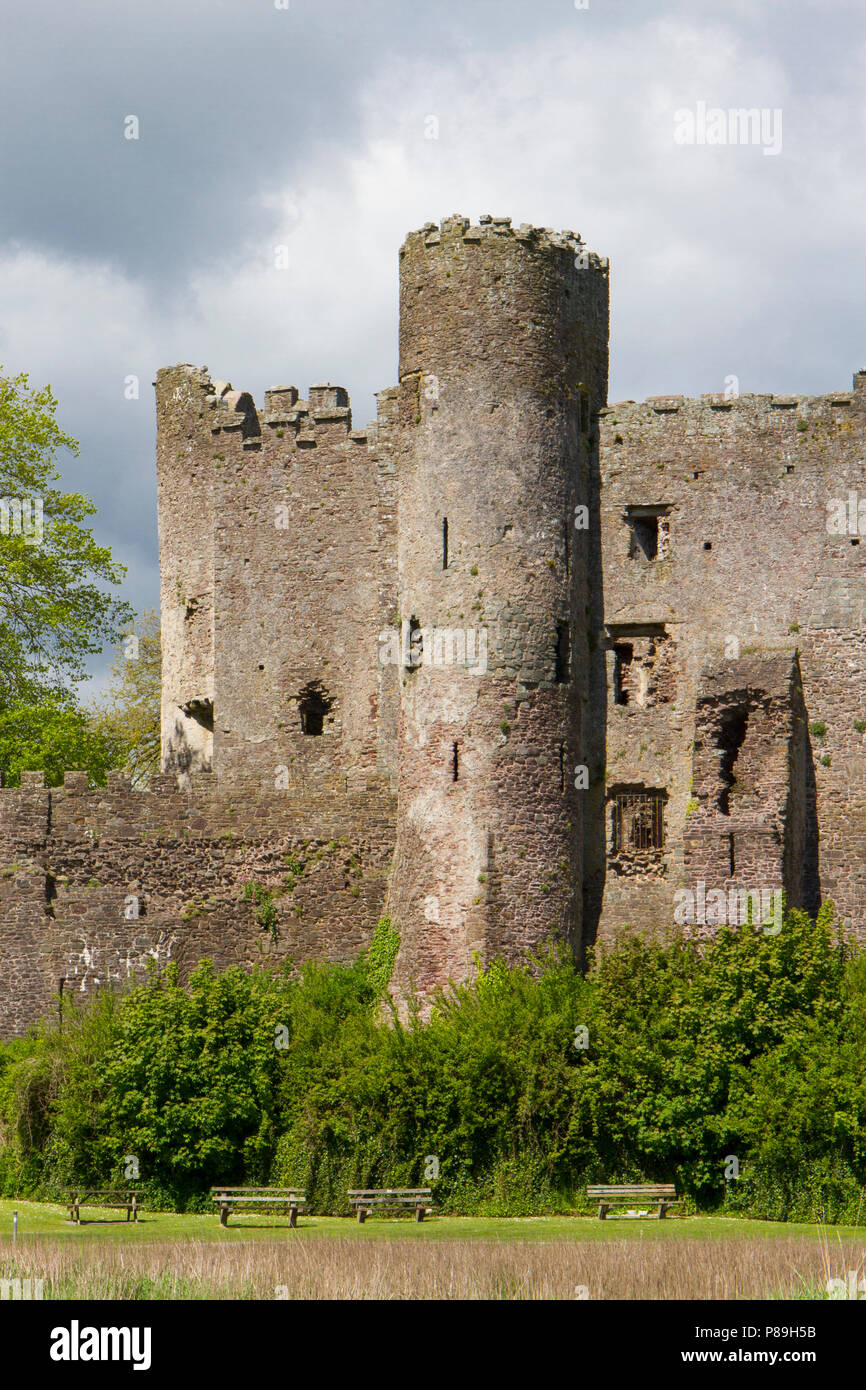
[[0, 217, 866, 1036]]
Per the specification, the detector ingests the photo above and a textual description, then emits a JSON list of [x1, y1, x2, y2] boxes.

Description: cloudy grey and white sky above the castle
[[0, 0, 866, 684]]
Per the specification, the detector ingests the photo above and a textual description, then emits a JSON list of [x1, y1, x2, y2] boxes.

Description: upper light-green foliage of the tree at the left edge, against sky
[[0, 373, 131, 709]]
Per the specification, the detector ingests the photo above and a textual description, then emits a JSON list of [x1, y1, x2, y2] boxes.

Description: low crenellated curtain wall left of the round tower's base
[[0, 773, 395, 1037]]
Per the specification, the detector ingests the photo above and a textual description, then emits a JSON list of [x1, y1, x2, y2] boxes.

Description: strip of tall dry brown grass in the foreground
[[0, 1237, 866, 1300]]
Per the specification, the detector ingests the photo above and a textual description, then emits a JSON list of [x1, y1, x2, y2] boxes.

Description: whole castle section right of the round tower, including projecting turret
[[587, 386, 866, 937]]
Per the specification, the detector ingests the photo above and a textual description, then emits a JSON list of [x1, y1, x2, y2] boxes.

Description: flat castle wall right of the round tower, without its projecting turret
[[594, 374, 866, 935]]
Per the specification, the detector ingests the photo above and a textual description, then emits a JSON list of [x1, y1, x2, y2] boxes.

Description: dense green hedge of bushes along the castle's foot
[[0, 908, 866, 1220]]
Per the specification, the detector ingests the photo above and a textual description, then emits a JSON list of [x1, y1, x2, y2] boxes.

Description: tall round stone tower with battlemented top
[[389, 217, 609, 994]]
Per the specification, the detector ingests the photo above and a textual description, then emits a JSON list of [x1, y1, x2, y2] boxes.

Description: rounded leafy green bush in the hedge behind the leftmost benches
[[69, 960, 297, 1209]]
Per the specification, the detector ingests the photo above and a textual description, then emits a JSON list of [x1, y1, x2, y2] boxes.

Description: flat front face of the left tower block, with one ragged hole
[[213, 386, 393, 796]]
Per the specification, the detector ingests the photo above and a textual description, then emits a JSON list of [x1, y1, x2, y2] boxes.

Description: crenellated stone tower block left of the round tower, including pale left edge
[[157, 367, 396, 796]]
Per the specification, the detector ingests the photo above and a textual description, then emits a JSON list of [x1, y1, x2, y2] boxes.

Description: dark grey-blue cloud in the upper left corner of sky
[[0, 0, 563, 281]]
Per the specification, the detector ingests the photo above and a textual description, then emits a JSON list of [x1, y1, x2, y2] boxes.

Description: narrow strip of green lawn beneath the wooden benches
[[0, 1200, 866, 1243]]
